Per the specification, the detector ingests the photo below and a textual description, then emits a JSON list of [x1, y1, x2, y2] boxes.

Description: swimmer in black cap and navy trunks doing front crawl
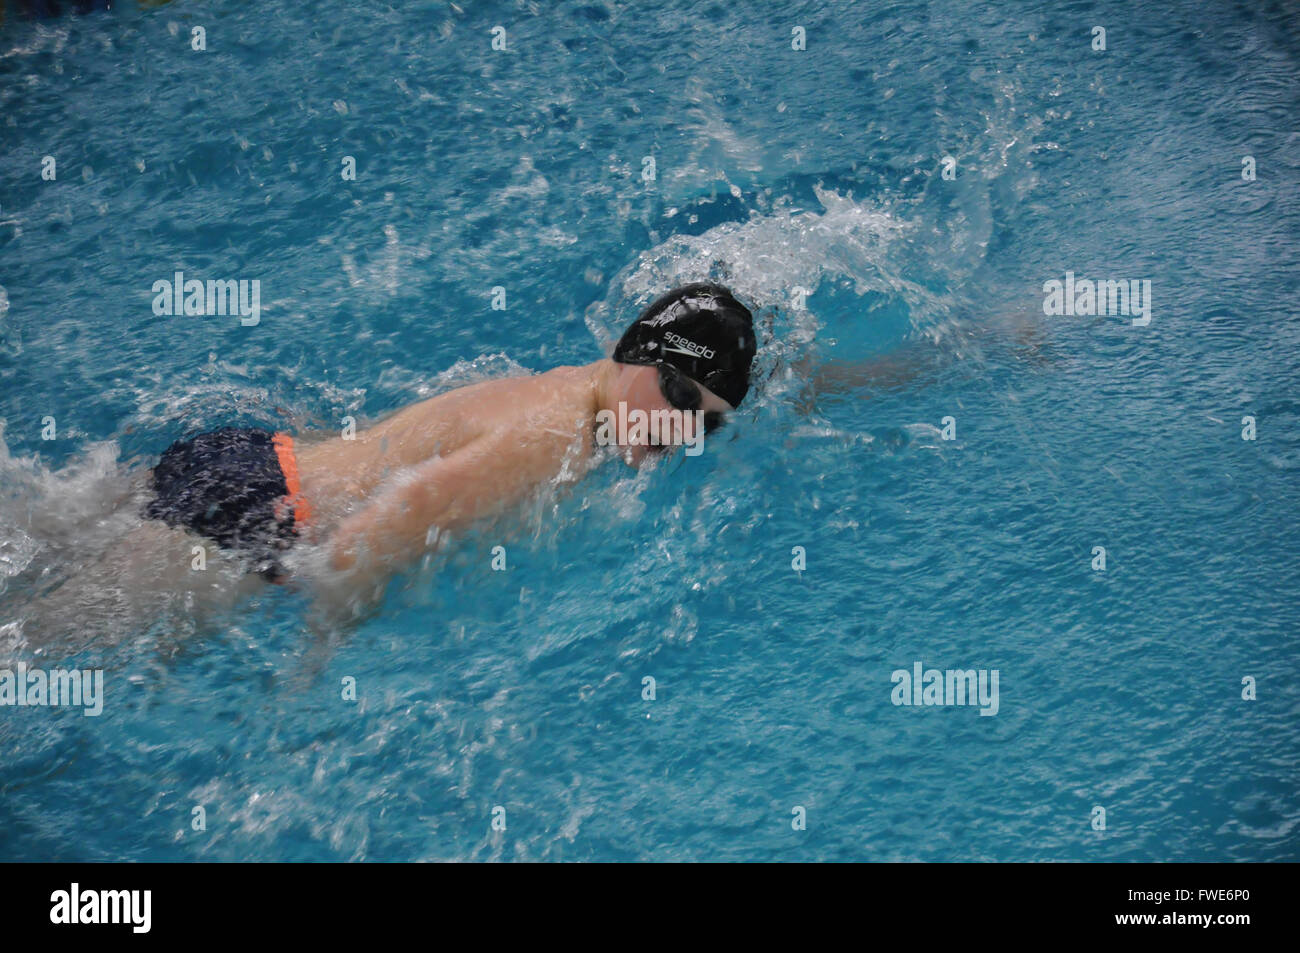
[[10, 282, 757, 642]]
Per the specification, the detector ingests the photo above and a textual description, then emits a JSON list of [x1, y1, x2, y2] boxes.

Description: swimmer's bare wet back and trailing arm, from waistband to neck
[[296, 365, 601, 584]]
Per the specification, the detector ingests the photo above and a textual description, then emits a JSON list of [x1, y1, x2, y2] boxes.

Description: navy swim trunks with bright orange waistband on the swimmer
[[144, 426, 308, 580]]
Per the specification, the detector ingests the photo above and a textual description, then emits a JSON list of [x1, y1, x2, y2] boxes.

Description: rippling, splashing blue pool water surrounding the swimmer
[[0, 0, 1300, 861]]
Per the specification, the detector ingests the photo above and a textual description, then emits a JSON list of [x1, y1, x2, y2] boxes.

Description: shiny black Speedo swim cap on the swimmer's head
[[614, 281, 758, 407]]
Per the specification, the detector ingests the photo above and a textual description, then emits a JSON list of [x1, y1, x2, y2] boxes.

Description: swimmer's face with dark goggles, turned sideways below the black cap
[[610, 364, 733, 467]]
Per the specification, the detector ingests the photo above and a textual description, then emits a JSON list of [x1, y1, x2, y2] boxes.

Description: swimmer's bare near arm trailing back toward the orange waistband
[[328, 438, 515, 585]]
